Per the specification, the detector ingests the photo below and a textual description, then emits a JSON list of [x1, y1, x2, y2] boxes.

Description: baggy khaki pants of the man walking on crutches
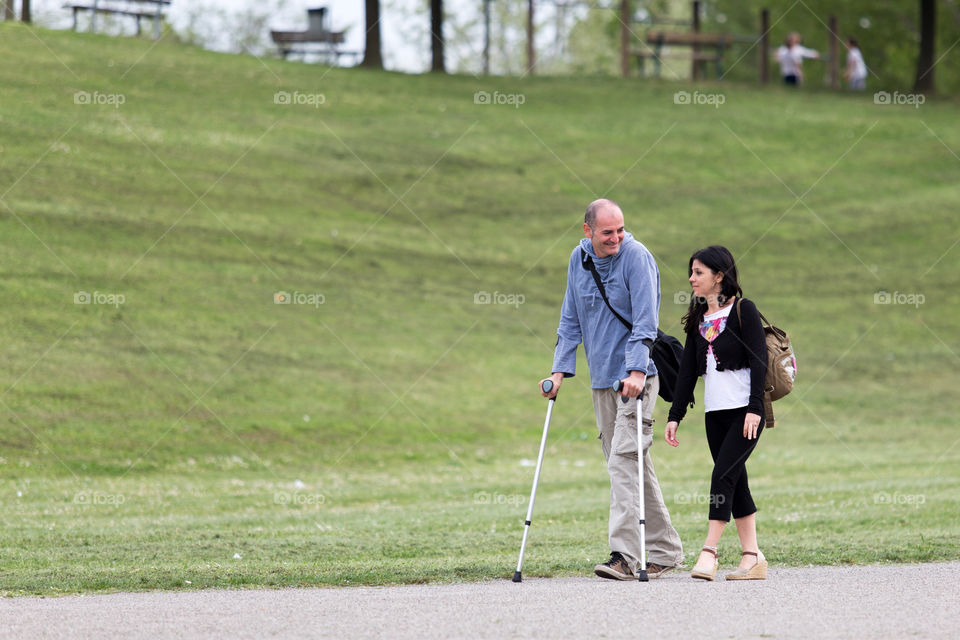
[[593, 376, 683, 572]]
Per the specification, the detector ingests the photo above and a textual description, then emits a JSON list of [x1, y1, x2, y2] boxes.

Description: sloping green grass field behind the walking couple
[[0, 24, 960, 595]]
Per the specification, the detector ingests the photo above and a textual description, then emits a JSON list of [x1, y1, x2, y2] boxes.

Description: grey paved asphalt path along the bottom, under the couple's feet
[[0, 562, 960, 640]]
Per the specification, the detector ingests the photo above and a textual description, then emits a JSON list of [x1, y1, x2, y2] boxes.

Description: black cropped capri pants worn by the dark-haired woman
[[704, 407, 765, 522]]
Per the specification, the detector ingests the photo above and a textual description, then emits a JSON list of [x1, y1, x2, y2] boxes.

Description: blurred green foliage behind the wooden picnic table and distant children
[[567, 0, 960, 94]]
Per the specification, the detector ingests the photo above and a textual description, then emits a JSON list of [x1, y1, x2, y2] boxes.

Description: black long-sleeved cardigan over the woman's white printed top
[[667, 298, 767, 422]]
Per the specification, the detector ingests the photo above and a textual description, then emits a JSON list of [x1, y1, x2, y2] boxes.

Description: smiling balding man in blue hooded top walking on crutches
[[541, 199, 683, 580]]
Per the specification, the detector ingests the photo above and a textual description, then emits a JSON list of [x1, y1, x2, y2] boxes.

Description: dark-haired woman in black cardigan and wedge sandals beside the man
[[664, 246, 767, 580]]
